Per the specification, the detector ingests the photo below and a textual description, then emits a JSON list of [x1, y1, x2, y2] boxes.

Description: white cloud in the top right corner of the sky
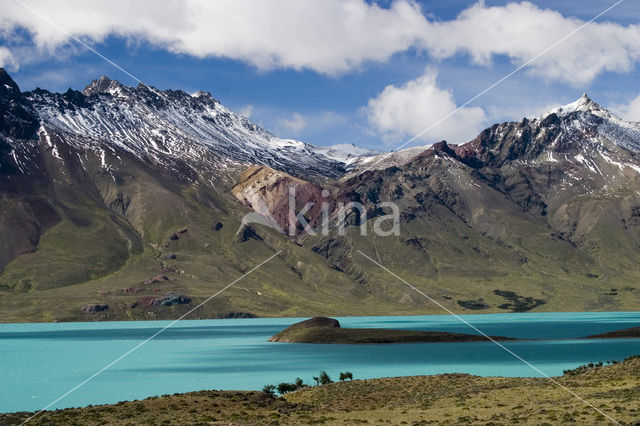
[[422, 2, 640, 85]]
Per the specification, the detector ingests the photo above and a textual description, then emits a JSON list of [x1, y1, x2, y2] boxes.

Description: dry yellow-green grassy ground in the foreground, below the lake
[[5, 357, 640, 425]]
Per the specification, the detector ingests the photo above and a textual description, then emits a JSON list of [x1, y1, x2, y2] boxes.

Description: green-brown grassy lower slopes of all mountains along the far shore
[[0, 150, 640, 322]]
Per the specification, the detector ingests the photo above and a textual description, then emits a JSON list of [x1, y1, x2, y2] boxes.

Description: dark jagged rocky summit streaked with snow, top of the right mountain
[[444, 95, 640, 208]]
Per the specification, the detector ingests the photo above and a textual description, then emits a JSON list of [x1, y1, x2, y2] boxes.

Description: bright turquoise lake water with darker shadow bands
[[0, 312, 640, 412]]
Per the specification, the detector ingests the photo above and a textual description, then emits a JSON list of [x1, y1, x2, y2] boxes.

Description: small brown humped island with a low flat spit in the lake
[[269, 317, 516, 344]]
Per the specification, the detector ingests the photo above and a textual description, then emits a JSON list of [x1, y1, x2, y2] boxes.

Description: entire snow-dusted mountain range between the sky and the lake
[[0, 70, 640, 321]]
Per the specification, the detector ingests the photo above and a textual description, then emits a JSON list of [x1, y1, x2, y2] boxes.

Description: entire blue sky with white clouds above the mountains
[[0, 0, 640, 151]]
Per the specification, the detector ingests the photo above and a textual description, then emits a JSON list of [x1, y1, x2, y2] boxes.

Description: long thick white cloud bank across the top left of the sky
[[0, 0, 426, 74]]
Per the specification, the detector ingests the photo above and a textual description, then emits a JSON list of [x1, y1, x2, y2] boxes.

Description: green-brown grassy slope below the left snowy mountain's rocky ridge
[[0, 151, 384, 322]]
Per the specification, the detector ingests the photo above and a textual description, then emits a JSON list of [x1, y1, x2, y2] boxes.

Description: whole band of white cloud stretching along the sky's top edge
[[0, 0, 640, 85]]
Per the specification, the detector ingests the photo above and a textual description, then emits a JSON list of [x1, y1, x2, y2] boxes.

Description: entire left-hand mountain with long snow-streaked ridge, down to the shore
[[0, 70, 380, 321]]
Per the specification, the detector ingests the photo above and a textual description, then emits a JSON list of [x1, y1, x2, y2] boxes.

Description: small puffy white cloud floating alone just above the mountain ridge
[[365, 68, 486, 144]]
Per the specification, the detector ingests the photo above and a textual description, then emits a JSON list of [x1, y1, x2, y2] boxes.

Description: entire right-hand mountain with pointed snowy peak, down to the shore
[[232, 95, 640, 311]]
